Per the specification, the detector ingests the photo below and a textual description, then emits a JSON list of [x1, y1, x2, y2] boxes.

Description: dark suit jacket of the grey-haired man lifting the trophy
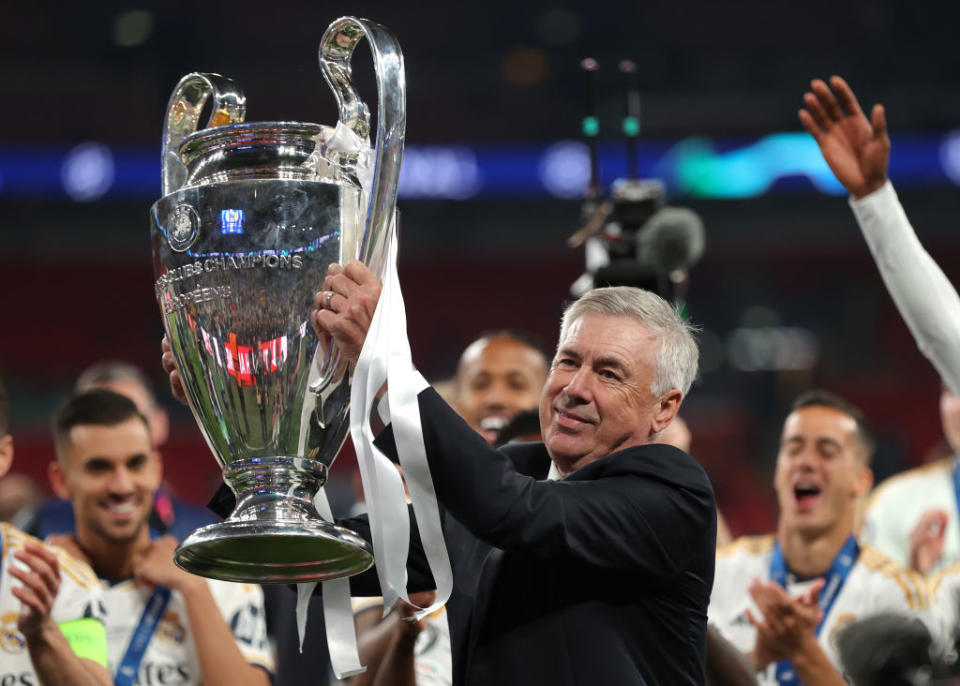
[[344, 389, 716, 686]]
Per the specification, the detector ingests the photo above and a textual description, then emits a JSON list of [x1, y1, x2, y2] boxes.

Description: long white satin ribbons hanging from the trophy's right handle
[[297, 122, 453, 678]]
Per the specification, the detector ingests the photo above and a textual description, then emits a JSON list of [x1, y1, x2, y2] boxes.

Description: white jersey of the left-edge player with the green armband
[[0, 522, 103, 686]]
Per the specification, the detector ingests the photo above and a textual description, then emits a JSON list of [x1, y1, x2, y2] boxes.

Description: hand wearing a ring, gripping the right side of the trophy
[[311, 260, 382, 363]]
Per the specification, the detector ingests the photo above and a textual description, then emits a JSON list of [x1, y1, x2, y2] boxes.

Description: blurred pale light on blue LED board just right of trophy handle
[[397, 146, 481, 200]]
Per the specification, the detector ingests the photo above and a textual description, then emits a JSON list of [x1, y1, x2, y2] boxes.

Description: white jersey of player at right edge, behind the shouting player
[[860, 458, 960, 573]]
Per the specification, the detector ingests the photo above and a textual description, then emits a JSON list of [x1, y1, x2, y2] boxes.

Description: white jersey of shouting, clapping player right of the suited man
[[707, 536, 930, 684]]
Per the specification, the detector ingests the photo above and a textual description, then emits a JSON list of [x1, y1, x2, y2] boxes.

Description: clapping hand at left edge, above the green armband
[[9, 542, 60, 640]]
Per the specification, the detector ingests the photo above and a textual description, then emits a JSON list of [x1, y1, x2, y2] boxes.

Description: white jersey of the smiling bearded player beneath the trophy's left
[[104, 579, 274, 686]]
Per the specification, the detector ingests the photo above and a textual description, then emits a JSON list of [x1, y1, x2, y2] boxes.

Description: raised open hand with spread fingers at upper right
[[799, 76, 890, 199]]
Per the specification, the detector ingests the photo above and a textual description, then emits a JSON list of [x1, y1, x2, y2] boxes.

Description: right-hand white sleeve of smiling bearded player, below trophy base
[[208, 580, 276, 674]]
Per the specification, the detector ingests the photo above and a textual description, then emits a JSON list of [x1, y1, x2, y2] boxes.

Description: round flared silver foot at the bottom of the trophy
[[173, 520, 373, 584]]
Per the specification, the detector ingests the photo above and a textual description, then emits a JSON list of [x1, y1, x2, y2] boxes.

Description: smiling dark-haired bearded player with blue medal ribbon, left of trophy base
[[50, 390, 273, 686]]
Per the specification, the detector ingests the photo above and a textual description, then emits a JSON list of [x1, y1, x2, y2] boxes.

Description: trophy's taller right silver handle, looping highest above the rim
[[320, 17, 407, 275]]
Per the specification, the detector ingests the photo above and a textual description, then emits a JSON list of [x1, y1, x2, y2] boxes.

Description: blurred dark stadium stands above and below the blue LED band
[[0, 0, 960, 533]]
